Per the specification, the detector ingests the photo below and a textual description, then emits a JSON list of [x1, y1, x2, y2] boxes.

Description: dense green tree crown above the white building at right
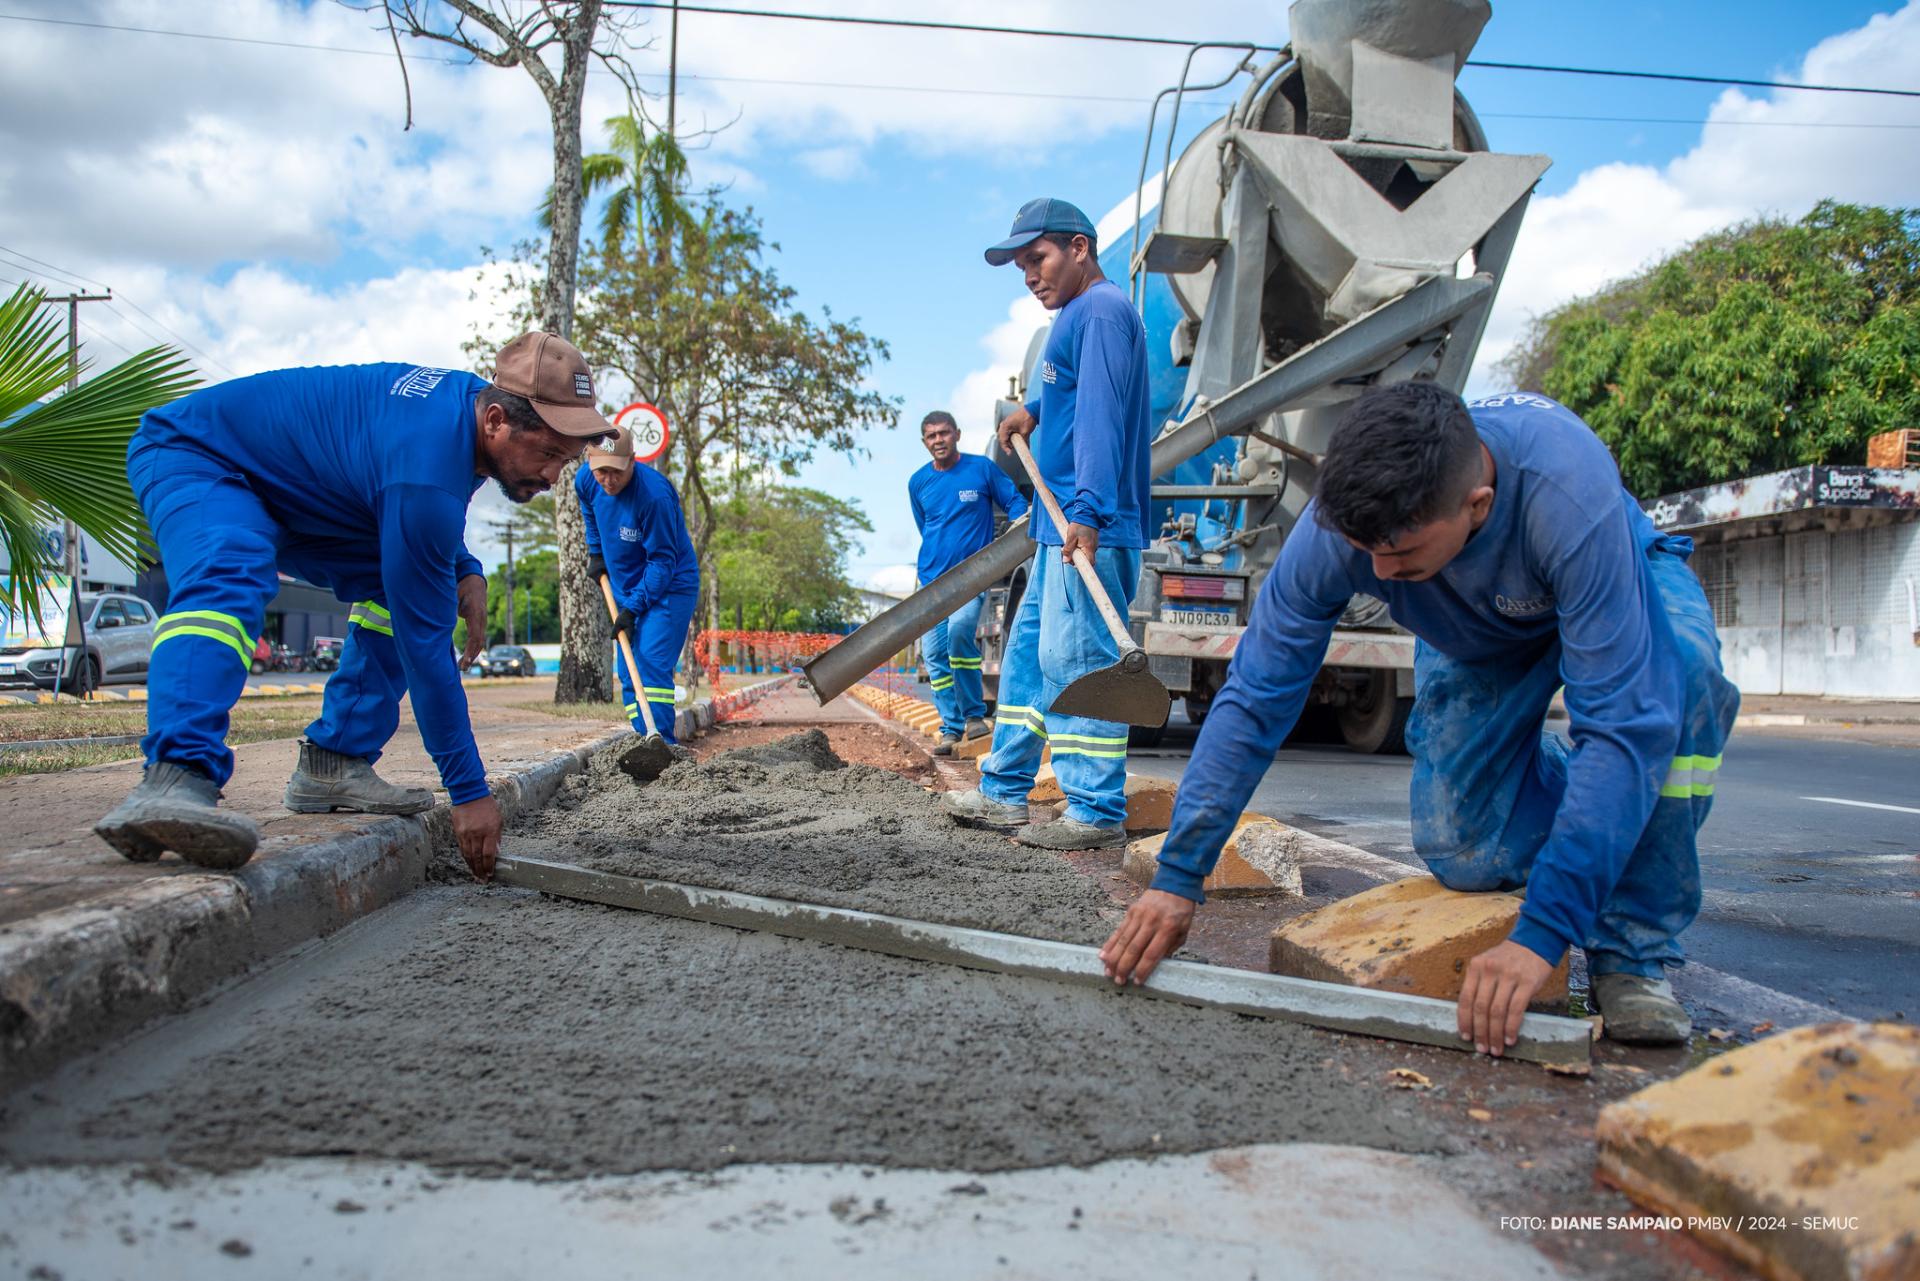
[[1501, 202, 1920, 497]]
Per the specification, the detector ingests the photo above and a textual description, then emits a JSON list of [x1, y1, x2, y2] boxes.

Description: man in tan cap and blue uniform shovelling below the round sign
[[574, 432, 701, 743]]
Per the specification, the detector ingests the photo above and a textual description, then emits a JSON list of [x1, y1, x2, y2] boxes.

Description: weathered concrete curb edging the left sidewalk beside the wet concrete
[[0, 730, 628, 1091]]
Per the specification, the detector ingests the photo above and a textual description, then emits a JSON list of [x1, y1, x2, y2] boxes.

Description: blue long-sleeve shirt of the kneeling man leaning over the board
[[1154, 394, 1692, 962]]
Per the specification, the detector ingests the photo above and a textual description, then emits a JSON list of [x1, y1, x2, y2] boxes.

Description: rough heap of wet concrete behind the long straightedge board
[[505, 730, 1119, 943]]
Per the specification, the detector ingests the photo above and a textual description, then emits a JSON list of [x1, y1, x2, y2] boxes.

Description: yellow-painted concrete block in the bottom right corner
[[1594, 1024, 1920, 1281]]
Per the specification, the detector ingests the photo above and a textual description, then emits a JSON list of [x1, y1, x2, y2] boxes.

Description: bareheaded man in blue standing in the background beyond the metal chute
[[906, 409, 1027, 757]]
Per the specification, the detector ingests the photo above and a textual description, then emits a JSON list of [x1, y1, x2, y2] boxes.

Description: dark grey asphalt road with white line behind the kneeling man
[[1129, 720, 1920, 1018]]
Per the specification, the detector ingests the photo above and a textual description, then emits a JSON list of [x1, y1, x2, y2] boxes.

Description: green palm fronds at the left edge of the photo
[[0, 284, 200, 626]]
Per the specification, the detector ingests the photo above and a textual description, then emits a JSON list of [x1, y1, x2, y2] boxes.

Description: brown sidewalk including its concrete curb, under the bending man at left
[[0, 680, 630, 1083]]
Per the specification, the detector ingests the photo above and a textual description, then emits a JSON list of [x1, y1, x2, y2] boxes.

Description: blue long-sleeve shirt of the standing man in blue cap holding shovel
[[1027, 280, 1154, 547]]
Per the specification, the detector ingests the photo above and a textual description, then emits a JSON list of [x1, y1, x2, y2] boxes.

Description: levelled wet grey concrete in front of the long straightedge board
[[0, 887, 1444, 1177]]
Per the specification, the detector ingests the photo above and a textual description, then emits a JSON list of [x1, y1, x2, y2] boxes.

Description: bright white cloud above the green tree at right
[[1473, 0, 1920, 392]]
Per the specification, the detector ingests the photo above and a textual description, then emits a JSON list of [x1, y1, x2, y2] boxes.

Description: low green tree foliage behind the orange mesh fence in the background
[[712, 484, 874, 632]]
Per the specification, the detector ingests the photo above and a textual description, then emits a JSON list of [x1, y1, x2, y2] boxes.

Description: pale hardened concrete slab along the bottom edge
[[0, 1145, 1559, 1281]]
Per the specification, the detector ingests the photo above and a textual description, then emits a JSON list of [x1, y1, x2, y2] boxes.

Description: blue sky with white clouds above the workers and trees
[[0, 0, 1920, 590]]
